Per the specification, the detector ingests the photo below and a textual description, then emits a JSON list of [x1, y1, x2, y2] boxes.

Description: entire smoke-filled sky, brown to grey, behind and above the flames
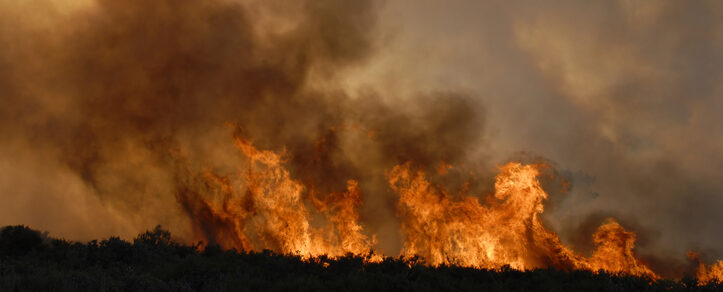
[[0, 0, 723, 266]]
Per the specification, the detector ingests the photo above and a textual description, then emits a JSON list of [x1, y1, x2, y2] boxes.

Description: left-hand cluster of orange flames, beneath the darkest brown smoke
[[179, 138, 374, 258]]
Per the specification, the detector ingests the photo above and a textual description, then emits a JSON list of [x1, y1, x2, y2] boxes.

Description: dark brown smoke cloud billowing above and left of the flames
[[0, 0, 483, 250]]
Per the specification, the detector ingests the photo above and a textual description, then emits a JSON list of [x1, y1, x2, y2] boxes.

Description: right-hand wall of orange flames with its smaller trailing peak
[[387, 162, 658, 279]]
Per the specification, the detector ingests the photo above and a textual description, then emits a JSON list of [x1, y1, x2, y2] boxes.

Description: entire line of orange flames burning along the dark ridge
[[178, 133, 723, 283]]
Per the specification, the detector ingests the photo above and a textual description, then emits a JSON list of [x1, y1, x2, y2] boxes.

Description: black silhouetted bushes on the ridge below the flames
[[0, 226, 723, 291]]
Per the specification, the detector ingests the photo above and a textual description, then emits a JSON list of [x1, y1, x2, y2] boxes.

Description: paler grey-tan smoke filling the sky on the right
[[368, 1, 723, 261]]
